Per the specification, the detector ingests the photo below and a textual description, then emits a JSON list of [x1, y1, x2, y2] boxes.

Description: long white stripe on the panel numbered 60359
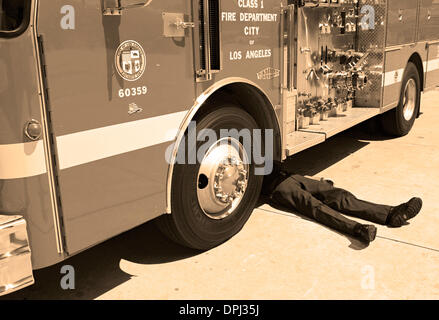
[[56, 111, 187, 170]]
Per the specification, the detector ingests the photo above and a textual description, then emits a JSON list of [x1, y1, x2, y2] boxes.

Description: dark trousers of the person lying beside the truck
[[271, 175, 392, 236]]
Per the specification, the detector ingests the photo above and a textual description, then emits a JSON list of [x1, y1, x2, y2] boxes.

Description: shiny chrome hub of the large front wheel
[[197, 138, 250, 219]]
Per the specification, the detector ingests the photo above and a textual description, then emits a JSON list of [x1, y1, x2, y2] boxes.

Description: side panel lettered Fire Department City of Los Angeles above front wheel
[[195, 0, 285, 106]]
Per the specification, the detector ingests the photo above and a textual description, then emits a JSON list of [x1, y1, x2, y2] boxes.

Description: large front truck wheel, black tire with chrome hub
[[156, 104, 263, 250]]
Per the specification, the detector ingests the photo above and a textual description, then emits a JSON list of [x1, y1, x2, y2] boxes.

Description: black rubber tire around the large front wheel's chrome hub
[[156, 104, 263, 250]]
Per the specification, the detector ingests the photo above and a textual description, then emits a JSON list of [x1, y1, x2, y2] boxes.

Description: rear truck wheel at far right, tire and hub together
[[382, 62, 421, 137]]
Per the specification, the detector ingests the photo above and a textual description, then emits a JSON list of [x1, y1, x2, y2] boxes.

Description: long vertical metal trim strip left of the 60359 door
[[31, 0, 64, 254]]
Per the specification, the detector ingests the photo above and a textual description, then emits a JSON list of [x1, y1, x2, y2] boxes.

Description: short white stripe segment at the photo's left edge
[[0, 140, 47, 180]]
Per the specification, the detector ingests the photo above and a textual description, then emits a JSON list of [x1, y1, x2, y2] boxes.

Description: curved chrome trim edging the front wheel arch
[[166, 77, 283, 214]]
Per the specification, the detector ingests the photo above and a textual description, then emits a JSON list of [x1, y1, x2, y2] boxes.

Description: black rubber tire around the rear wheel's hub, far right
[[381, 62, 421, 137]]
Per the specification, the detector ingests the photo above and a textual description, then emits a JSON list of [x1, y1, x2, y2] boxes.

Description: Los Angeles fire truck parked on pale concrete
[[0, 0, 439, 294]]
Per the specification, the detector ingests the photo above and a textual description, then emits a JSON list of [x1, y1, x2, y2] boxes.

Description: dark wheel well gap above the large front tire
[[194, 82, 282, 161]]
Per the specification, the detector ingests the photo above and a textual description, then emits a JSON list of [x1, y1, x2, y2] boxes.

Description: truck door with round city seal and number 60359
[[38, 0, 195, 253]]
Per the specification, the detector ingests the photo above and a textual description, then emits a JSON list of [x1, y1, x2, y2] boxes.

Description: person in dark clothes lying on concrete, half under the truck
[[262, 164, 422, 243]]
